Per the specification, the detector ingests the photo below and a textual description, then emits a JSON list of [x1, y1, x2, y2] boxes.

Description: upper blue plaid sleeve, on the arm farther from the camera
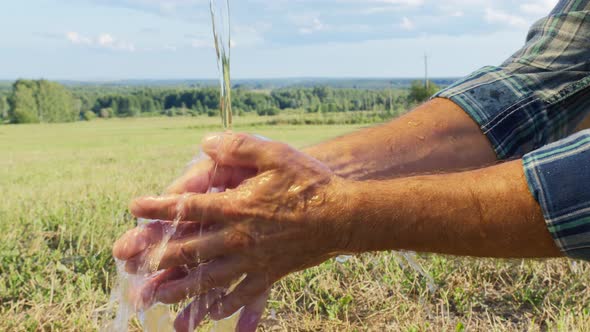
[[435, 0, 590, 159]]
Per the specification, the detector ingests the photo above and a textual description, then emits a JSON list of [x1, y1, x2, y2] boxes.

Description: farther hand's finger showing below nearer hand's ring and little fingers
[[174, 290, 223, 332]]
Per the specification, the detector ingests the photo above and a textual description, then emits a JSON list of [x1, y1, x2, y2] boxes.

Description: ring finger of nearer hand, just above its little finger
[[155, 256, 247, 304]]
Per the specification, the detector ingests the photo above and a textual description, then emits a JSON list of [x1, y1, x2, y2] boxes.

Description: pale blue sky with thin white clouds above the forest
[[0, 0, 557, 80]]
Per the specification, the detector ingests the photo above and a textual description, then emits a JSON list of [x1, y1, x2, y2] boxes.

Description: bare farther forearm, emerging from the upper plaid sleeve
[[305, 98, 496, 180]]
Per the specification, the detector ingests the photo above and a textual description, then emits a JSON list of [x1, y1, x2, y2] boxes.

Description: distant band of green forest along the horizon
[[0, 79, 444, 123]]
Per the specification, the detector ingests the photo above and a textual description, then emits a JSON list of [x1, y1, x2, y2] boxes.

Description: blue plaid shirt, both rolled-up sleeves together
[[435, 0, 590, 260]]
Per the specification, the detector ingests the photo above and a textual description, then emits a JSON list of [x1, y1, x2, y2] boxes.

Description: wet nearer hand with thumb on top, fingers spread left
[[123, 134, 349, 319]]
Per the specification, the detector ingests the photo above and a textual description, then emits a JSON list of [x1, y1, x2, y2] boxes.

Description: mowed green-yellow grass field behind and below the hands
[[0, 118, 590, 331]]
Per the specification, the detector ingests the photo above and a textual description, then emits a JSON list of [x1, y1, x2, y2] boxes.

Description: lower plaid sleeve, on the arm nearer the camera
[[523, 130, 590, 261]]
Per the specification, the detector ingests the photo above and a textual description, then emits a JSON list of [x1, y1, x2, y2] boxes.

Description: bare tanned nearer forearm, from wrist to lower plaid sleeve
[[348, 161, 561, 258]]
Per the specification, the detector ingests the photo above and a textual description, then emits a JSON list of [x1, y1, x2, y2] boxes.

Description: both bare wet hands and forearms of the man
[[114, 99, 560, 331]]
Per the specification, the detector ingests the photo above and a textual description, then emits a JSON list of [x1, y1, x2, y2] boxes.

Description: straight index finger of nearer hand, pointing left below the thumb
[[129, 193, 239, 224]]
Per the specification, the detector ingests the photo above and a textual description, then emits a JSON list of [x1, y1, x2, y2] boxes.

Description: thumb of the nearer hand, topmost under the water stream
[[202, 133, 294, 171]]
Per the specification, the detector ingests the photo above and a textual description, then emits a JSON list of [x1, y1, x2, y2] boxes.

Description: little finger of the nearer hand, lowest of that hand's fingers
[[210, 274, 272, 320]]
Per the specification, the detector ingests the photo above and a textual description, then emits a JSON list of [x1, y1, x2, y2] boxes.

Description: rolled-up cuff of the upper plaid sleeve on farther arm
[[434, 63, 590, 160]]
